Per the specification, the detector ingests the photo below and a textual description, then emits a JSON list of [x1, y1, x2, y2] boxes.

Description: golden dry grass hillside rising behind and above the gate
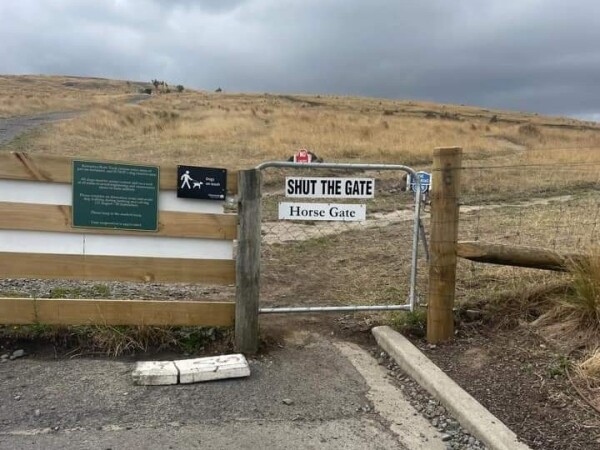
[[6, 78, 600, 191]]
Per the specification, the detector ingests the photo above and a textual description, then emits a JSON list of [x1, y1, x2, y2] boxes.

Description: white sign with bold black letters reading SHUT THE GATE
[[285, 177, 375, 198]]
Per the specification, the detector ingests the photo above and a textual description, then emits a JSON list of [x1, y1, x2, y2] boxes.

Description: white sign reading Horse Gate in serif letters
[[279, 202, 367, 222]]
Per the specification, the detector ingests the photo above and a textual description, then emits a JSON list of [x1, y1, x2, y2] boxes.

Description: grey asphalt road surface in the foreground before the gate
[[0, 333, 445, 450]]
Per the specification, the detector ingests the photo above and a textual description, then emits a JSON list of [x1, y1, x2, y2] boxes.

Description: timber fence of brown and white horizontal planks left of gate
[[0, 153, 246, 351]]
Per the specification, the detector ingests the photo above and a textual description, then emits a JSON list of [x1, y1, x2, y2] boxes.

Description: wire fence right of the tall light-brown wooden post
[[457, 148, 600, 301]]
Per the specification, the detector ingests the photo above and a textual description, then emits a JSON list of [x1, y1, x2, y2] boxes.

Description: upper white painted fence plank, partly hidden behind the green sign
[[0, 180, 224, 214]]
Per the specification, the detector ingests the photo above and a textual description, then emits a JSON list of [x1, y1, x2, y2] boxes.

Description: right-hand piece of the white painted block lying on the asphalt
[[173, 353, 250, 384]]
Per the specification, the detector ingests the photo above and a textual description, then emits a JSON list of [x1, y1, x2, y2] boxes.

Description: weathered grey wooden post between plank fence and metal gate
[[235, 169, 261, 353]]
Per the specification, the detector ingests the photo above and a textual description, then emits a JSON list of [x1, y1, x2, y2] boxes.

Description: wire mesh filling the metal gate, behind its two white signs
[[261, 168, 427, 307]]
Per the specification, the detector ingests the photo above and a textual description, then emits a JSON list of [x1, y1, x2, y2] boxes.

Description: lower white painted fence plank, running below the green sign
[[0, 230, 233, 259]]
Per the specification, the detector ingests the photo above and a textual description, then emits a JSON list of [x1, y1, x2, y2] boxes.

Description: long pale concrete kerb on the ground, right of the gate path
[[372, 326, 529, 450]]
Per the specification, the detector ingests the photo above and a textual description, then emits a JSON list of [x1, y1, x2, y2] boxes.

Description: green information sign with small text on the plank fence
[[73, 161, 159, 231]]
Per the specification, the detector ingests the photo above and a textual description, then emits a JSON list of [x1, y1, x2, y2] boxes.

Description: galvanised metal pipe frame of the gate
[[256, 161, 422, 314]]
